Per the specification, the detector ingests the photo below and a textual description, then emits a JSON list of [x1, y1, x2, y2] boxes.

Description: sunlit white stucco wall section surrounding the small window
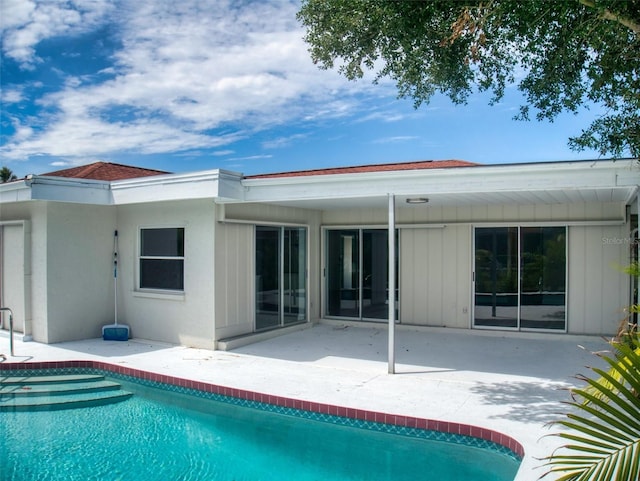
[[117, 200, 219, 349]]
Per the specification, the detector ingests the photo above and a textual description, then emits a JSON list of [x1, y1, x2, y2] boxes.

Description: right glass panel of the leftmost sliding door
[[283, 228, 307, 324]]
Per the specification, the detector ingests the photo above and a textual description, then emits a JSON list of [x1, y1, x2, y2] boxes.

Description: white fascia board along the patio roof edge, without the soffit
[[243, 161, 639, 202]]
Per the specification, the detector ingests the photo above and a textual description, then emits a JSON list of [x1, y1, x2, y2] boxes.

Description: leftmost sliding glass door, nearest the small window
[[255, 226, 307, 331]]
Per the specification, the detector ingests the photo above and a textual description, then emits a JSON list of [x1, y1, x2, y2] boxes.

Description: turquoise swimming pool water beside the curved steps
[[0, 368, 520, 481]]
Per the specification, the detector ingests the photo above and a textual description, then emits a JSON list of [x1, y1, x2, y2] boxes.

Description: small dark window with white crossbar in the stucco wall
[[140, 227, 184, 291]]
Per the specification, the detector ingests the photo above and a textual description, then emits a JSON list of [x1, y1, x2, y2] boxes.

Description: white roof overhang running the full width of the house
[[0, 159, 640, 210]]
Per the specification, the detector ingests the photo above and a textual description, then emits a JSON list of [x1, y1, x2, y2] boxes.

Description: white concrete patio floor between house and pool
[[0, 322, 608, 481]]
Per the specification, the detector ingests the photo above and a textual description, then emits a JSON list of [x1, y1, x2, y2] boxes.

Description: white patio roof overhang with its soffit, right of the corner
[[235, 160, 640, 210]]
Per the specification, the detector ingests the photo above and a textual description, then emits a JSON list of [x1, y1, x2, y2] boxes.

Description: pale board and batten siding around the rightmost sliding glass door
[[322, 202, 633, 334]]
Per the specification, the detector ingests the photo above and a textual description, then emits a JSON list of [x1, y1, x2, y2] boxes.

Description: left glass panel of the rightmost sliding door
[[474, 227, 518, 328]]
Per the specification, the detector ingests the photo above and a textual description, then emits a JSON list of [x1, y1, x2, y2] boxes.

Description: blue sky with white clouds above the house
[[0, 0, 598, 177]]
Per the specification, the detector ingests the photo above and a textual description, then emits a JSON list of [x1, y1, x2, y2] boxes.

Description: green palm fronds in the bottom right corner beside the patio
[[542, 322, 640, 481]]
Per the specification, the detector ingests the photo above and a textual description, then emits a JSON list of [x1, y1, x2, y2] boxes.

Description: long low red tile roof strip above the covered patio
[[245, 160, 478, 179]]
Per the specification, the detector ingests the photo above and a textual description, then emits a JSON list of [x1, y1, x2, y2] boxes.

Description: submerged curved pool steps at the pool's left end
[[0, 374, 132, 412]]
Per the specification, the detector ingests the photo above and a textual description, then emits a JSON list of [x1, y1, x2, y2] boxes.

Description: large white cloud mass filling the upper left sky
[[0, 0, 384, 159]]
